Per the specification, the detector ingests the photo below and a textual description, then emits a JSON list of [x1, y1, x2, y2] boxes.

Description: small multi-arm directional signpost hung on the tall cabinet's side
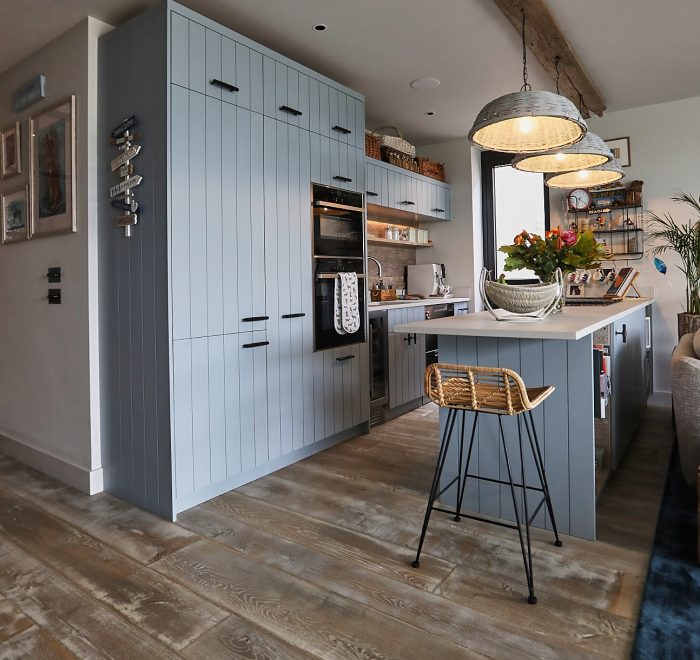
[[109, 115, 143, 238]]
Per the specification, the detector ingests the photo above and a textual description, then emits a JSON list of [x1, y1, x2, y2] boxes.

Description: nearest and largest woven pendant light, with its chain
[[469, 10, 588, 154]]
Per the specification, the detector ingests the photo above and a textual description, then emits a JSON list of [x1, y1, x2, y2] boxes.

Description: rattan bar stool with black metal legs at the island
[[412, 364, 562, 604]]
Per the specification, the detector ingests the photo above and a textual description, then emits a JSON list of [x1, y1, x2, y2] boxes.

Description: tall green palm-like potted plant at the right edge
[[649, 192, 700, 338]]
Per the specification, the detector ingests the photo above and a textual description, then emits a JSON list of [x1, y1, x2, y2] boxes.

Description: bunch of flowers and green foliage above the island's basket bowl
[[499, 229, 605, 282]]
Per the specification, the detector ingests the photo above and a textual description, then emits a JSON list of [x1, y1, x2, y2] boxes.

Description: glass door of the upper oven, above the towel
[[313, 206, 364, 257]]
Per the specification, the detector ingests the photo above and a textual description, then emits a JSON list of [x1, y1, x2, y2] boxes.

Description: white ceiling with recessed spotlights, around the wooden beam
[[0, 0, 700, 144]]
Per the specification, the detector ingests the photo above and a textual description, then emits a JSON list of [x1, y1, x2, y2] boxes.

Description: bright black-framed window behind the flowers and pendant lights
[[481, 151, 549, 283]]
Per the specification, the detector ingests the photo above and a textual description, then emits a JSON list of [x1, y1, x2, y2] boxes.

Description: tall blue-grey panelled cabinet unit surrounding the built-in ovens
[[99, 2, 369, 517]]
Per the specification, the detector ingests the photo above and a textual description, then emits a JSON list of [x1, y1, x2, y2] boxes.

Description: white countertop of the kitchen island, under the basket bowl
[[394, 298, 654, 340]]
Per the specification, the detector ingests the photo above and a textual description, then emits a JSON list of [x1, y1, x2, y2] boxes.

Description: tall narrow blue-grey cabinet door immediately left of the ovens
[[265, 118, 314, 458]]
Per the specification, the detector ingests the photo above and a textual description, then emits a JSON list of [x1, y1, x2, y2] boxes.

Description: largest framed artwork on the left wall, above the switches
[[29, 96, 77, 237]]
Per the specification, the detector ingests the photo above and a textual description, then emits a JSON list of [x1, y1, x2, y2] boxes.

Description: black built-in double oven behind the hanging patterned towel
[[311, 184, 367, 351]]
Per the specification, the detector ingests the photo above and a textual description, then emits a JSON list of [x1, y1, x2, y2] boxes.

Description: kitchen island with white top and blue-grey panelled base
[[394, 298, 653, 539]]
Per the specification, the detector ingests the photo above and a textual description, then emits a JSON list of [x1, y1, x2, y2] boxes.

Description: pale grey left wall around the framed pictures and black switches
[[0, 18, 110, 492]]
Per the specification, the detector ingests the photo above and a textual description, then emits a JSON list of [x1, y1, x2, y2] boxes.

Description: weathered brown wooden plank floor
[[0, 406, 672, 660]]
